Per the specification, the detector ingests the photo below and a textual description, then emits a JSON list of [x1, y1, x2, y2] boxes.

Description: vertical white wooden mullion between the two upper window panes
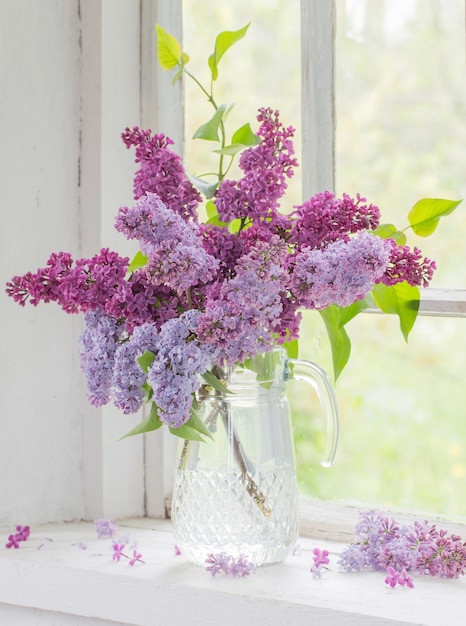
[[301, 0, 335, 199]]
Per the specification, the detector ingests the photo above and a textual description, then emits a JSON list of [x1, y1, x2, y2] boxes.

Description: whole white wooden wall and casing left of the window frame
[[0, 0, 159, 524]]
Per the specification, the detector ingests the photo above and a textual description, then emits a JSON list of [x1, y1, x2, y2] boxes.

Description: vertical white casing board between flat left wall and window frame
[[80, 0, 144, 519]]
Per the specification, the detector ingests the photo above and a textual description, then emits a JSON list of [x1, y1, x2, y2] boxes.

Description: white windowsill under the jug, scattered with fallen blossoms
[[0, 519, 466, 626]]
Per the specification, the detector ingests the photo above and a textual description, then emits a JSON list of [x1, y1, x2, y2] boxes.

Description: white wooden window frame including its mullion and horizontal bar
[[147, 0, 466, 540]]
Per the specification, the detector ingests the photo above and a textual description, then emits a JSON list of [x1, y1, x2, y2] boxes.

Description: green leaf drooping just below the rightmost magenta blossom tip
[[372, 281, 420, 341]]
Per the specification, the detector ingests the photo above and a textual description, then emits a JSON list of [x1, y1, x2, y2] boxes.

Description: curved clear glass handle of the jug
[[288, 359, 338, 467]]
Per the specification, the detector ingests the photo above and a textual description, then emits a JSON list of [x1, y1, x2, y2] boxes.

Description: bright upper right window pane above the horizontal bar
[[336, 0, 466, 288]]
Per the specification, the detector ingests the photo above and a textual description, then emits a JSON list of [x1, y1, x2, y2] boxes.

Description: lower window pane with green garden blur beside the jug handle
[[290, 314, 466, 516]]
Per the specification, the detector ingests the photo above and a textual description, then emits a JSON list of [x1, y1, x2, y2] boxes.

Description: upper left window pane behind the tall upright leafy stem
[[183, 0, 301, 212]]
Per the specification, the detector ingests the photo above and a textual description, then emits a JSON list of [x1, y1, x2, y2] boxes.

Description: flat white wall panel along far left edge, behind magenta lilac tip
[[0, 0, 83, 524]]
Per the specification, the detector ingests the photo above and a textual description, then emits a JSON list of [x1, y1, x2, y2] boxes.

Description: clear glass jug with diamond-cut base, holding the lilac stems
[[172, 348, 338, 566]]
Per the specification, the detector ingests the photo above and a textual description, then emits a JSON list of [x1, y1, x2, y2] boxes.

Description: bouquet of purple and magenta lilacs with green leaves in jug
[[7, 26, 458, 439]]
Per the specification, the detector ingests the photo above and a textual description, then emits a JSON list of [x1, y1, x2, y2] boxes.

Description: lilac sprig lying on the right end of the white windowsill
[[339, 511, 466, 584]]
